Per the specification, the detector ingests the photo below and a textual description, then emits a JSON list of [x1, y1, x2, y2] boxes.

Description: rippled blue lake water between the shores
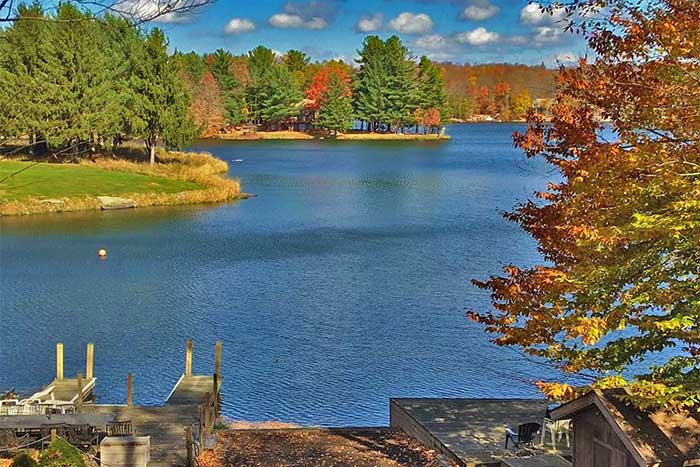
[[0, 124, 568, 426]]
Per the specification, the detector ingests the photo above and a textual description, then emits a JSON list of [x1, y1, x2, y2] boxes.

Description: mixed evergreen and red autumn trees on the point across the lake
[[174, 36, 448, 134]]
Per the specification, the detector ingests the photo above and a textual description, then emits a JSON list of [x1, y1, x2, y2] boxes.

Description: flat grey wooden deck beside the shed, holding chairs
[[389, 399, 547, 466]]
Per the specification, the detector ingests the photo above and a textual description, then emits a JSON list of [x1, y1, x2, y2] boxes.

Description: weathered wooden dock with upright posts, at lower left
[[0, 339, 222, 467]]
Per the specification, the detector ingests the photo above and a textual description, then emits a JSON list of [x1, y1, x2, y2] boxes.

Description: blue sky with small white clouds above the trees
[[149, 0, 586, 66]]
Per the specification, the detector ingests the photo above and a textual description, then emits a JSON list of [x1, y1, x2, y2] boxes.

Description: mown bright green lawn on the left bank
[[0, 161, 204, 202]]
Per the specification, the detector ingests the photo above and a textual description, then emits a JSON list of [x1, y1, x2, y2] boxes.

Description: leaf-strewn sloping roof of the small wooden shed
[[551, 389, 700, 466]]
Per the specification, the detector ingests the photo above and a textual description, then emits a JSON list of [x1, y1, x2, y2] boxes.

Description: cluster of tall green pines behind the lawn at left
[[0, 3, 197, 161]]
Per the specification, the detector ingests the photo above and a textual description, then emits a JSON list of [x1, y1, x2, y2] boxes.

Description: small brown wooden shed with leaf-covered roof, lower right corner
[[551, 389, 700, 467]]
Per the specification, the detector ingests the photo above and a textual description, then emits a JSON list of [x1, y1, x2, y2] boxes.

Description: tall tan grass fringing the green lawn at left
[[0, 149, 246, 218]]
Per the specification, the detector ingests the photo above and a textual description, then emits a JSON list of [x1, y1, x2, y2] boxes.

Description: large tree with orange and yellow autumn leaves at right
[[469, 0, 700, 410]]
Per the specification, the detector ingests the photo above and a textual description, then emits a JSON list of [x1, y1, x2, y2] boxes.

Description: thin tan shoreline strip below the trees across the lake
[[216, 131, 452, 141]]
